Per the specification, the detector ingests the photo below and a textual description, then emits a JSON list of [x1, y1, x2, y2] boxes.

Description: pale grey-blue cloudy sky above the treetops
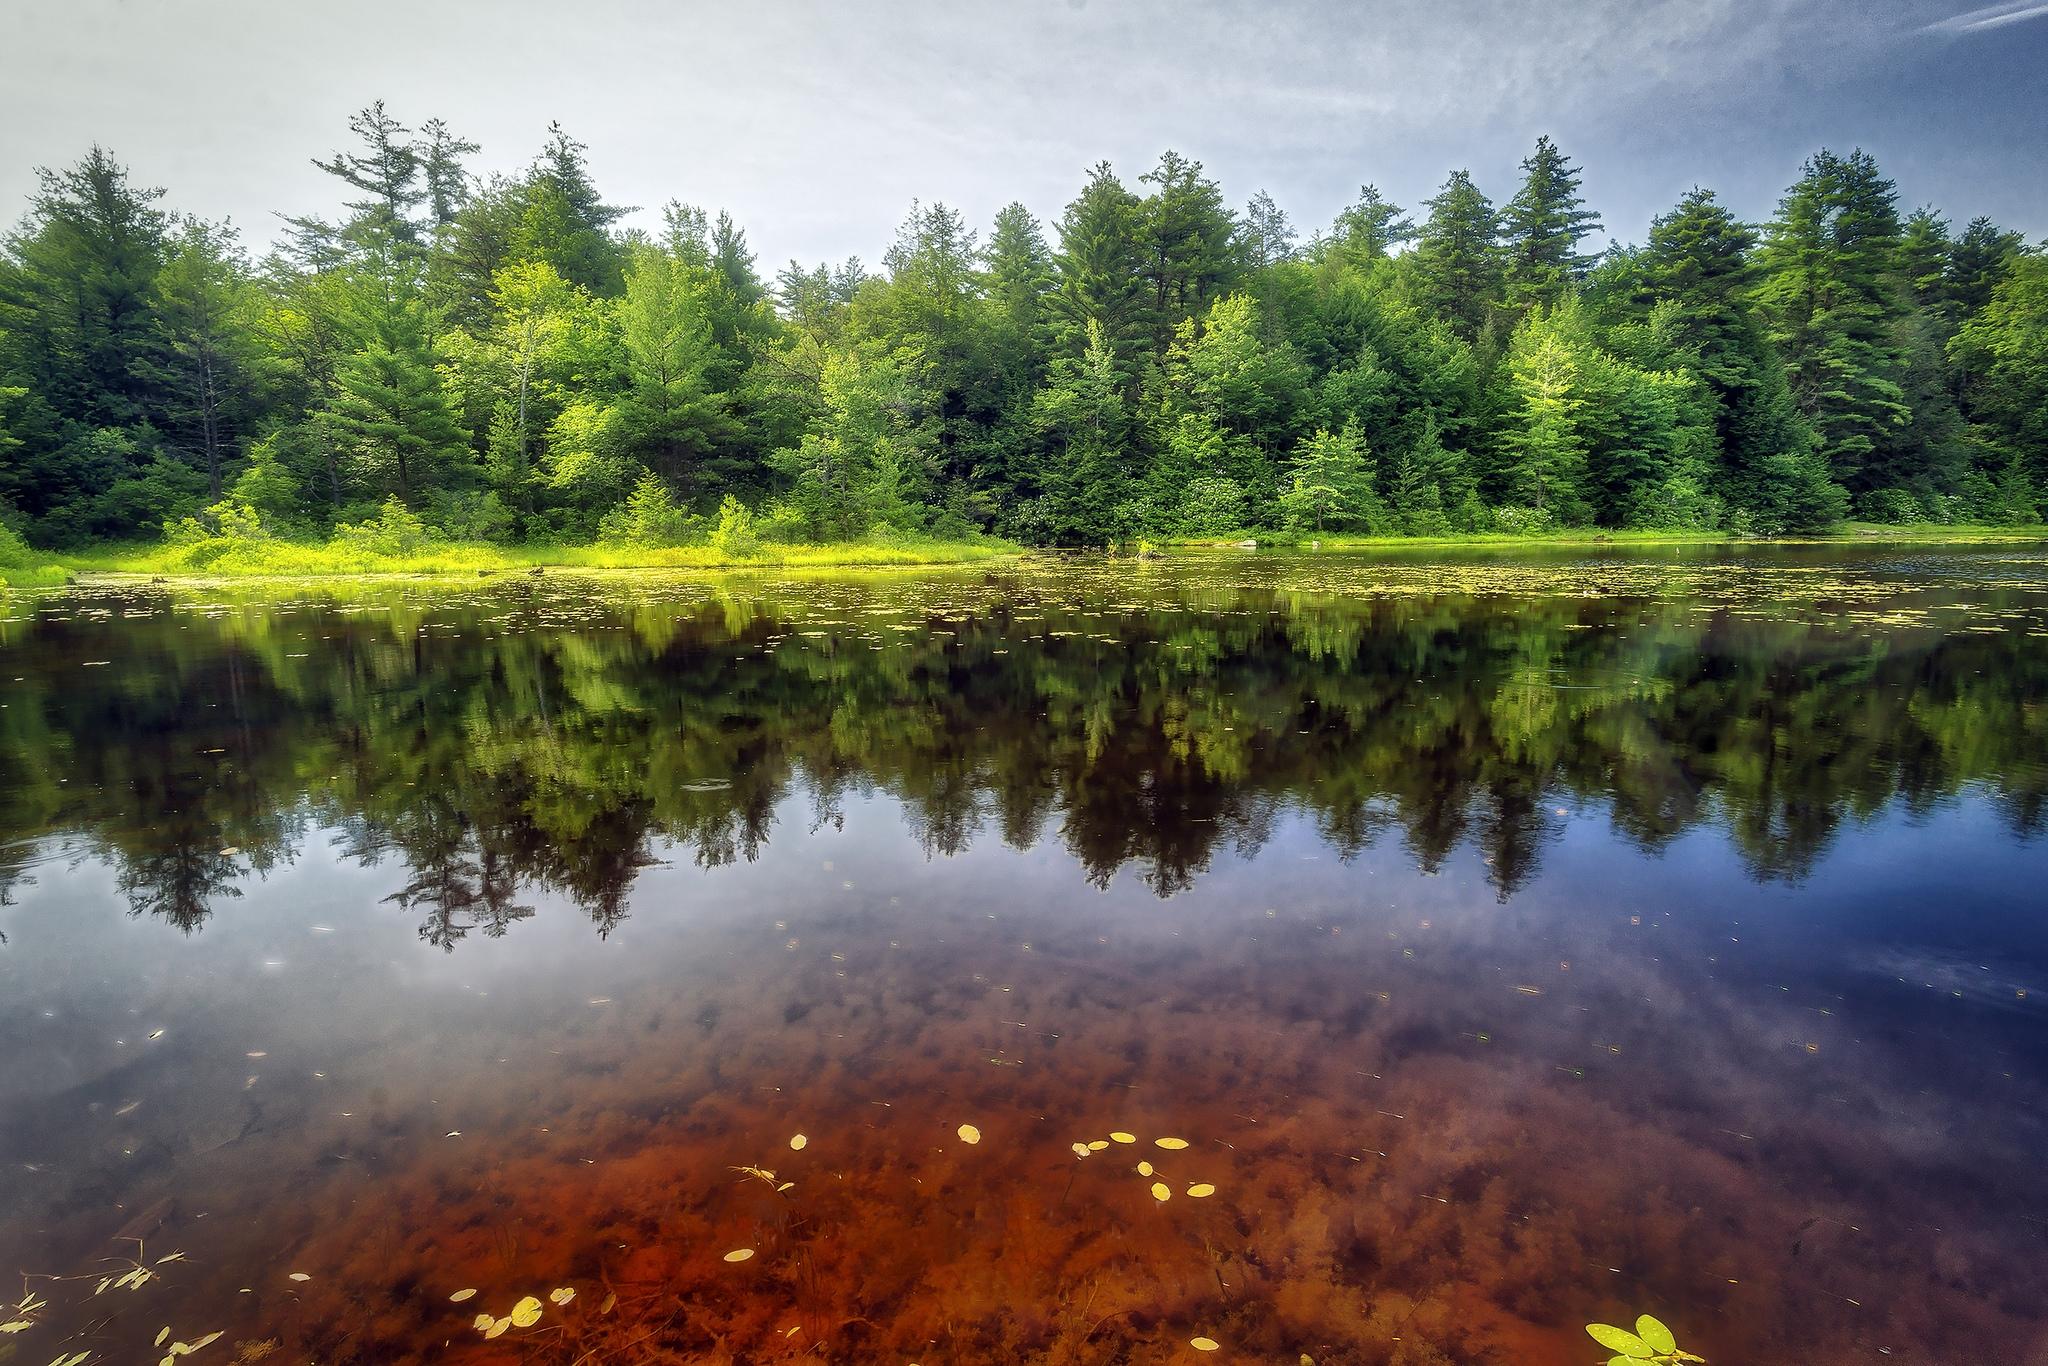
[[0, 0, 2048, 272]]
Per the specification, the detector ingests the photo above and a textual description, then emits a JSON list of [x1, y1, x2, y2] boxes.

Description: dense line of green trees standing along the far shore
[[0, 104, 2048, 545]]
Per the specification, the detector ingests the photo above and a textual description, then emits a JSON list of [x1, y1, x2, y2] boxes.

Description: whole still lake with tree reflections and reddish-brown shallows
[[0, 547, 2048, 1366]]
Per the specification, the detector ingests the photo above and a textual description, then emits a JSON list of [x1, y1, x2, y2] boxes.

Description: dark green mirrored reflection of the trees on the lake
[[0, 586, 2048, 946]]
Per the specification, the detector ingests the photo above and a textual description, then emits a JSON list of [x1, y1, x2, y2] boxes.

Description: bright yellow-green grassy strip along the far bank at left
[[61, 541, 1016, 578]]
